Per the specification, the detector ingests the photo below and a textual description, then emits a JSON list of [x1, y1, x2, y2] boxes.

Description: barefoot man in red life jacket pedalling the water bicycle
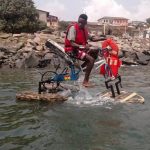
[[65, 14, 105, 87]]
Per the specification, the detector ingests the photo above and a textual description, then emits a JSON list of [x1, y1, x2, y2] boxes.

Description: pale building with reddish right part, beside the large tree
[[37, 9, 59, 28]]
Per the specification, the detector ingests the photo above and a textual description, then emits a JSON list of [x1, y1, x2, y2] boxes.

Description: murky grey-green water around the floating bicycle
[[0, 66, 150, 150]]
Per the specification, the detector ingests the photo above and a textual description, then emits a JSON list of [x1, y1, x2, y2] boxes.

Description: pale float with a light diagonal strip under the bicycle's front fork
[[100, 91, 145, 104]]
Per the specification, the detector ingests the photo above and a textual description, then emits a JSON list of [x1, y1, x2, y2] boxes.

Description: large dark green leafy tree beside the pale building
[[0, 0, 46, 33]]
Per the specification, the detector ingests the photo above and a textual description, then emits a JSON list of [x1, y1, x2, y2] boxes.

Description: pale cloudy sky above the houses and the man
[[33, 0, 150, 21]]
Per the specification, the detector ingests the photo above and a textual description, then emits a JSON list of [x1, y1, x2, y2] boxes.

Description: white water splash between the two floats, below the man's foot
[[61, 76, 115, 109]]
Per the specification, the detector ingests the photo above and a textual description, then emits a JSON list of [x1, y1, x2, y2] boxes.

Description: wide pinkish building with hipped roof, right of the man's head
[[98, 17, 129, 26]]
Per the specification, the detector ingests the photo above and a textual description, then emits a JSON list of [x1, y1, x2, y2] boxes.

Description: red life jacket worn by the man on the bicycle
[[65, 23, 88, 52]]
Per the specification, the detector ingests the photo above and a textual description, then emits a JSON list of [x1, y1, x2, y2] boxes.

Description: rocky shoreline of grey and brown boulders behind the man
[[0, 31, 150, 69]]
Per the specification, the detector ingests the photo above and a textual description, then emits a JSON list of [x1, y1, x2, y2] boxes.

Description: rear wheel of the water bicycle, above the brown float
[[41, 71, 59, 92]]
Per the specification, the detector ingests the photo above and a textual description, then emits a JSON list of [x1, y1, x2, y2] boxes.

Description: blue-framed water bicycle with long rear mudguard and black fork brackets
[[38, 40, 122, 97]]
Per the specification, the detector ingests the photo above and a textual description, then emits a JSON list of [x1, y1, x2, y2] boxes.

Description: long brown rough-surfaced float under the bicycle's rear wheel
[[16, 91, 67, 103]]
